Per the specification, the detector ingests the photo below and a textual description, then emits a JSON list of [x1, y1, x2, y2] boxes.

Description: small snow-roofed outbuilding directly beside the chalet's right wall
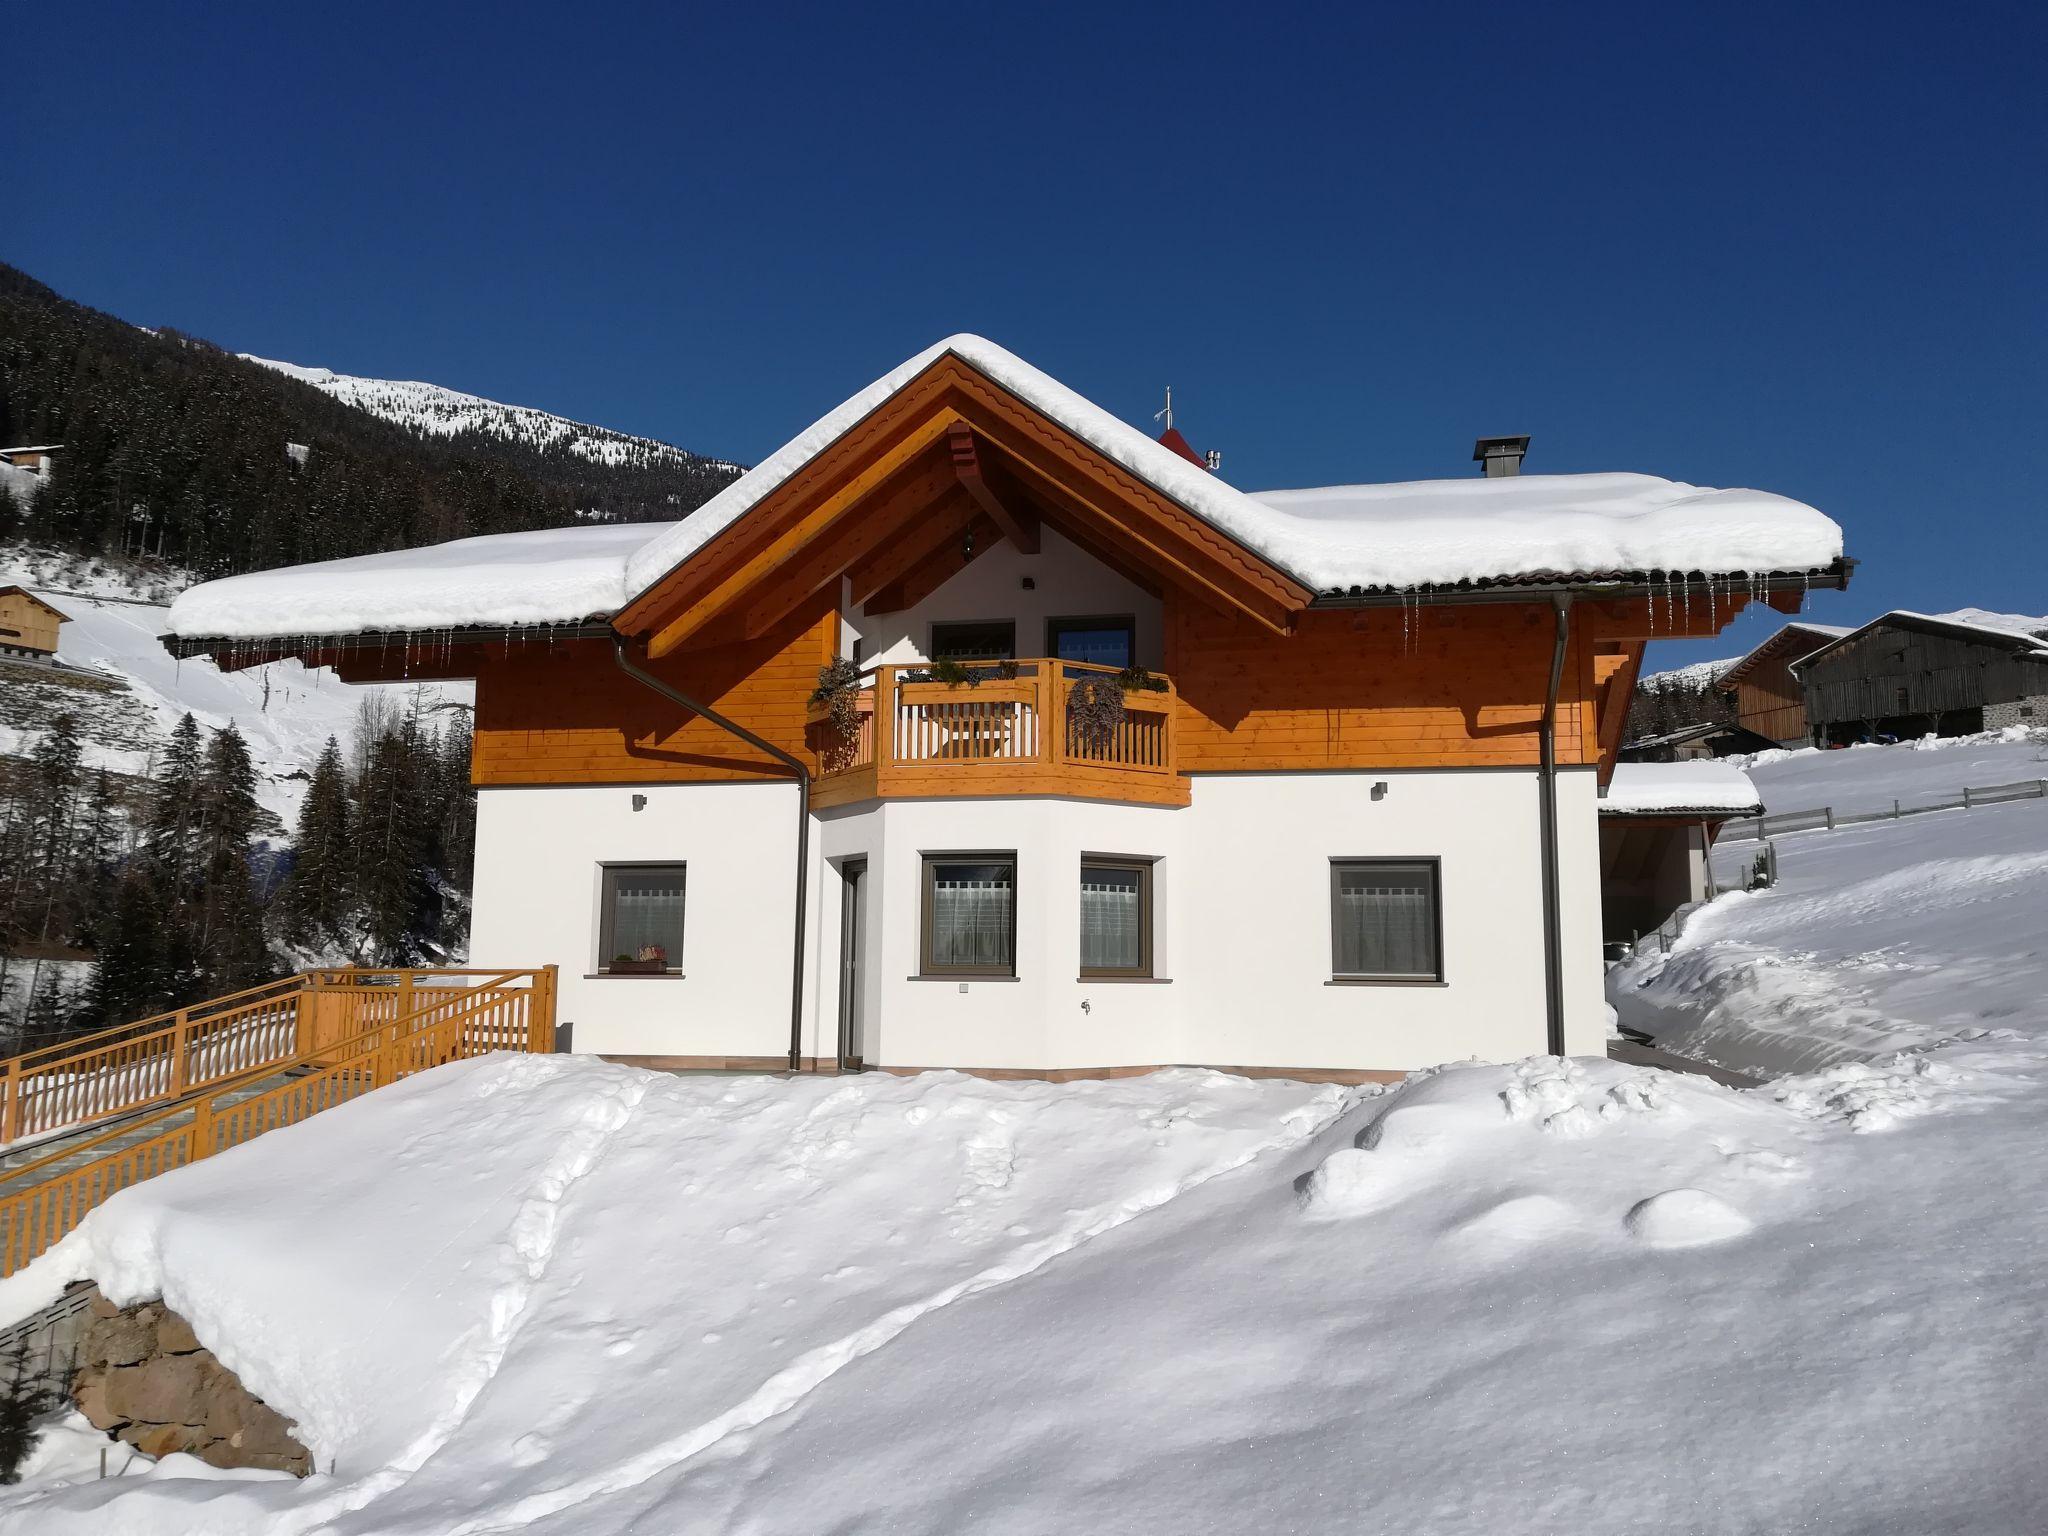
[[1599, 762, 1763, 944]]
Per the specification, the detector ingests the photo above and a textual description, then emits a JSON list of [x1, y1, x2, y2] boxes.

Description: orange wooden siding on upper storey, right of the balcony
[[1165, 600, 1599, 772]]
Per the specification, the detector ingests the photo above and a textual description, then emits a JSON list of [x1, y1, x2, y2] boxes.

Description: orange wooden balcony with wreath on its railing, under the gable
[[809, 659, 1188, 807]]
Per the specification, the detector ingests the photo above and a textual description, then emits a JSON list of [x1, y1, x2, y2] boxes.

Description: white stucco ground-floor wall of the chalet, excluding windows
[[471, 770, 1606, 1071]]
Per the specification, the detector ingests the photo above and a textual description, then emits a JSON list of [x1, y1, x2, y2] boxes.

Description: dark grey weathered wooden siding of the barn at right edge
[[1800, 625, 2048, 729]]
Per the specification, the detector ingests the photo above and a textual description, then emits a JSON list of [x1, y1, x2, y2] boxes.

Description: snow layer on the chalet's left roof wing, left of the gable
[[170, 522, 670, 639]]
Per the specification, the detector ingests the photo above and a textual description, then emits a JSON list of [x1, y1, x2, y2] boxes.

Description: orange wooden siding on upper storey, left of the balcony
[[471, 600, 838, 784]]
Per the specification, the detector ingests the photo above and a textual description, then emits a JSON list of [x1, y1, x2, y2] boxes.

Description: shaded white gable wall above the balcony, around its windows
[[842, 528, 1165, 670]]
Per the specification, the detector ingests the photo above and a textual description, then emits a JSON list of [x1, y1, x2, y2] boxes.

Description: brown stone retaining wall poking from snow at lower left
[[72, 1292, 313, 1477]]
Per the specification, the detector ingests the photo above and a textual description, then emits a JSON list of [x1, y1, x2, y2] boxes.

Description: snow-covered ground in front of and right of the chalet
[[0, 748, 2048, 1536]]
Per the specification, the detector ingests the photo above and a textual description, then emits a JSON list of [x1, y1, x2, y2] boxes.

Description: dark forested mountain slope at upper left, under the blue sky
[[0, 264, 737, 578]]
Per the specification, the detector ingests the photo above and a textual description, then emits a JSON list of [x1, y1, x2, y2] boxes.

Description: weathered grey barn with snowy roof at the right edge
[[1790, 608, 2048, 745]]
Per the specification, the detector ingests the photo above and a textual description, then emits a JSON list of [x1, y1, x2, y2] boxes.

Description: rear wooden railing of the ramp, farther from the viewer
[[0, 969, 544, 1145]]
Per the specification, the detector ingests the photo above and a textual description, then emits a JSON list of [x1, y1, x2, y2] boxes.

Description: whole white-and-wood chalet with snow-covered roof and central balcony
[[166, 336, 1849, 1081]]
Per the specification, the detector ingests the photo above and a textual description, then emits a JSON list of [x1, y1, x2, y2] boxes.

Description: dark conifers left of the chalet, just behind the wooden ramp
[[0, 698, 475, 1053]]
